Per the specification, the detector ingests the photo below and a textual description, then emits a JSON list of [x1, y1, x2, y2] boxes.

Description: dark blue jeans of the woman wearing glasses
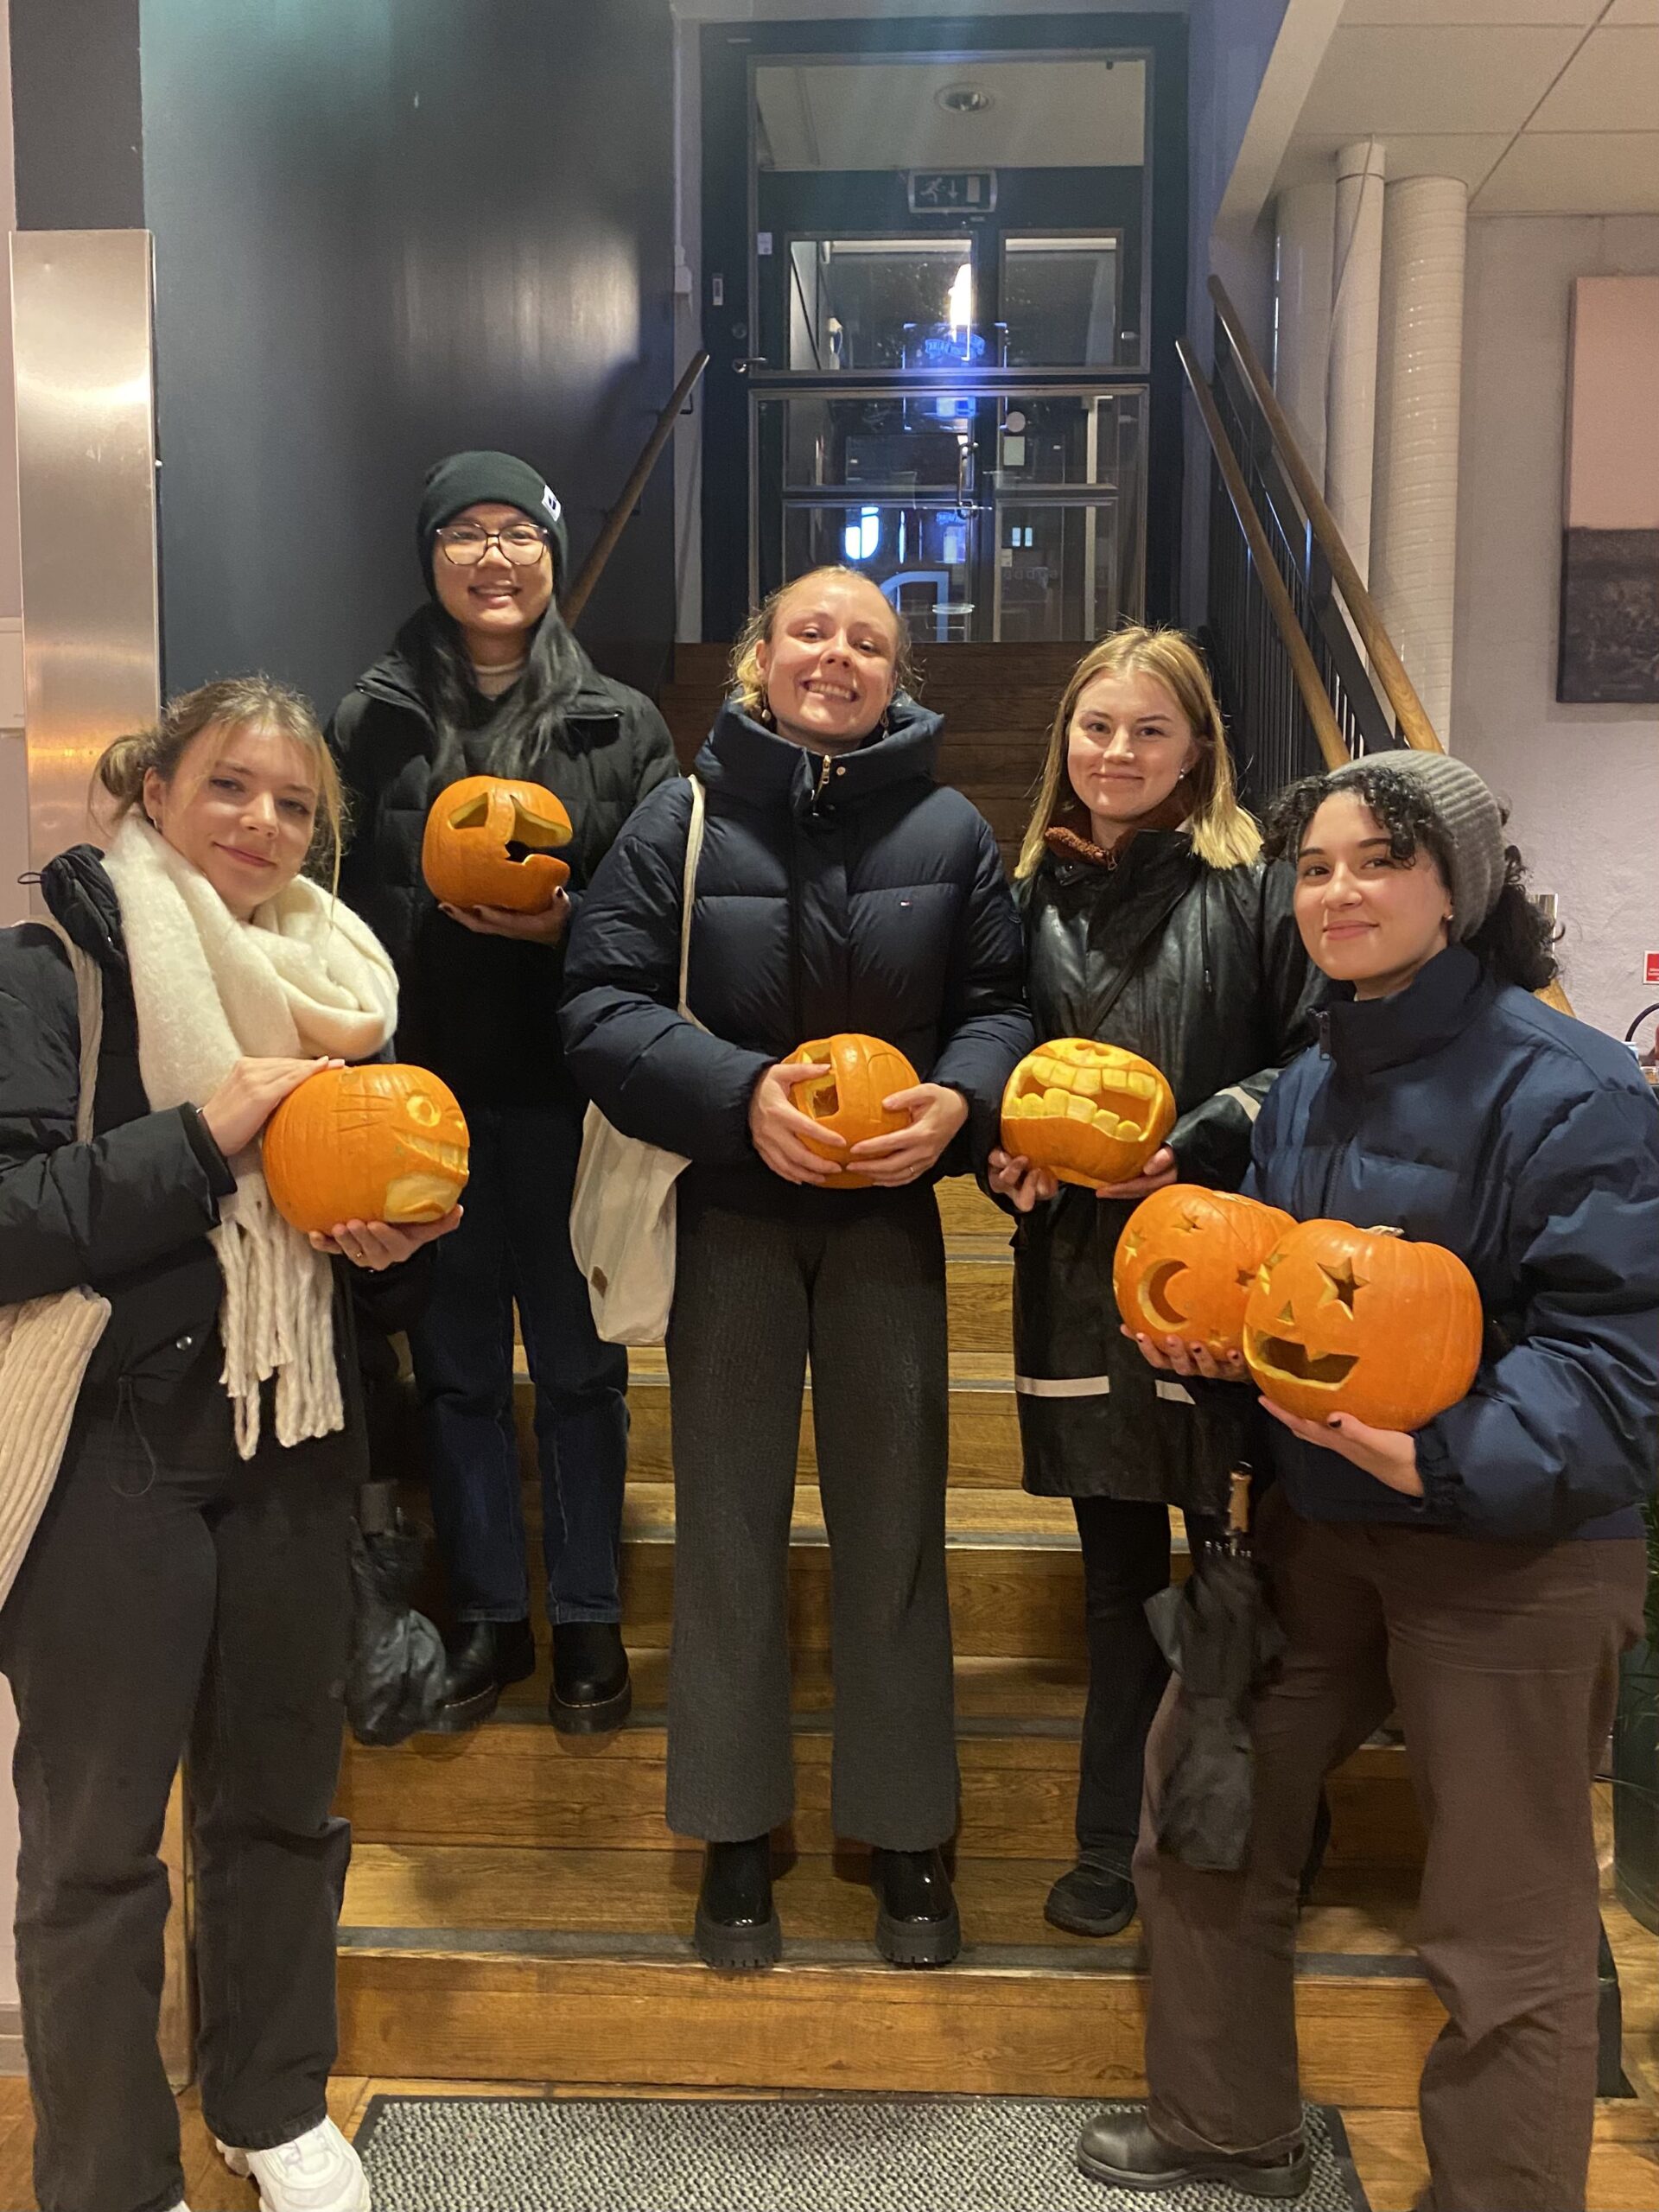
[[410, 1106, 628, 1626]]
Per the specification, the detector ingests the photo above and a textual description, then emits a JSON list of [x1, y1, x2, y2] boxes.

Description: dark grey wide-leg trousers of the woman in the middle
[[668, 1188, 957, 1852]]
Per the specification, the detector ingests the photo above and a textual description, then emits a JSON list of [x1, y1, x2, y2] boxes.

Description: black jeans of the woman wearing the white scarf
[[0, 1402, 352, 2212]]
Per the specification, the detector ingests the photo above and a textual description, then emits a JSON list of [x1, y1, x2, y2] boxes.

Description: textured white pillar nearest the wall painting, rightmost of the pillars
[[1371, 177, 1468, 746]]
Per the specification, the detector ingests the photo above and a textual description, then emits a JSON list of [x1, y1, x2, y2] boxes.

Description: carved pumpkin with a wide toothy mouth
[[1002, 1038, 1174, 1190]]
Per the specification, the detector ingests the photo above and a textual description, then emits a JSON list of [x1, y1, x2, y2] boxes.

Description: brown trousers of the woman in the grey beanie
[[1135, 1491, 1646, 2212]]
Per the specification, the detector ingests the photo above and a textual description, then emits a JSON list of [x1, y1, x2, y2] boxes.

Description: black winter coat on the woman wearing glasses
[[327, 617, 679, 1110]]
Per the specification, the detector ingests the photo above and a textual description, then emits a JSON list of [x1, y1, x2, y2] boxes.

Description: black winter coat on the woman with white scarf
[[0, 845, 427, 1473]]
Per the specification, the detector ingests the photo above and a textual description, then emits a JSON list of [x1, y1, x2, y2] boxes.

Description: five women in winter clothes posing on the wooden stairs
[[0, 454, 1659, 2212]]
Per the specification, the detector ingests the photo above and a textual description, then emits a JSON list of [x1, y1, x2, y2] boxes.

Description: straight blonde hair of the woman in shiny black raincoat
[[1013, 626, 1261, 878]]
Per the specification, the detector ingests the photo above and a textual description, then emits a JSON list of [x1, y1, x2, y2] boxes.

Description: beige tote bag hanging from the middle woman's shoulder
[[570, 777, 703, 1344]]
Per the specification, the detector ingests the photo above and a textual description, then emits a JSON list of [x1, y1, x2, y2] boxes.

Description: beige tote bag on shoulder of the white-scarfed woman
[[0, 923, 108, 1604]]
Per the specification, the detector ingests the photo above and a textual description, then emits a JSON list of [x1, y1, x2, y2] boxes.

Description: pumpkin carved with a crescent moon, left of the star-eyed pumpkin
[[1113, 1184, 1296, 1356]]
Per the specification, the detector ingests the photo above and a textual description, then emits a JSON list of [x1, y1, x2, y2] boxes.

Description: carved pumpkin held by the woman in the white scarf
[[264, 1062, 467, 1232]]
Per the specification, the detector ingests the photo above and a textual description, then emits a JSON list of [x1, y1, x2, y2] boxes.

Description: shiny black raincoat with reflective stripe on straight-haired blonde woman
[[1013, 830, 1319, 1510]]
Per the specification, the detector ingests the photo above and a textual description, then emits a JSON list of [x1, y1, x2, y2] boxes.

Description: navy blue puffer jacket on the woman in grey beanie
[[1245, 944, 1659, 1541]]
